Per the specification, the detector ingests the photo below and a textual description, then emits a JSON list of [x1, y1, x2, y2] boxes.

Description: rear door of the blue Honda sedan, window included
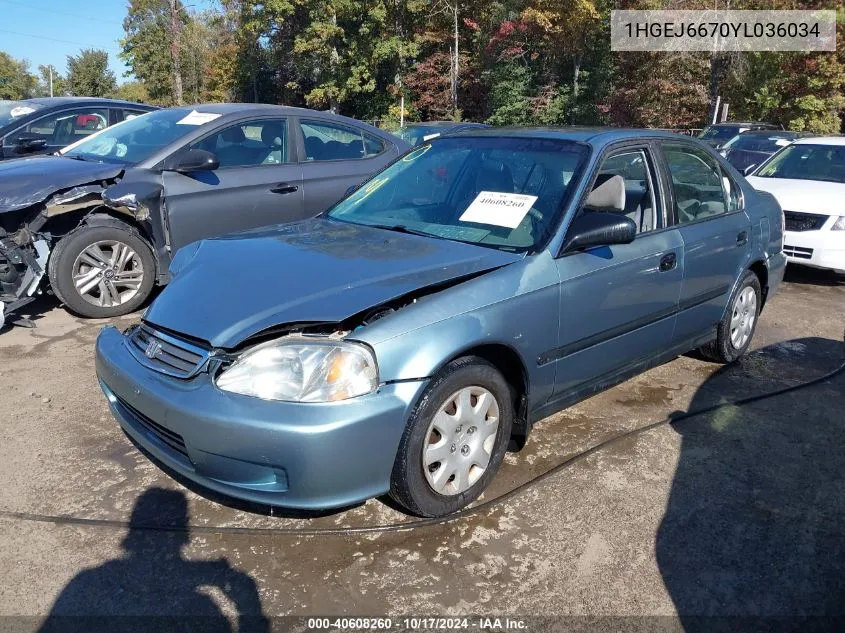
[[662, 140, 751, 343]]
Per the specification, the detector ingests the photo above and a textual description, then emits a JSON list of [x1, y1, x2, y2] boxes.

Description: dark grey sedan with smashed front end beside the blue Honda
[[0, 104, 408, 326]]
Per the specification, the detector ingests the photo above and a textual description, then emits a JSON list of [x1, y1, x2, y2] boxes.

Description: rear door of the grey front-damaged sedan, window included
[[299, 118, 397, 215]]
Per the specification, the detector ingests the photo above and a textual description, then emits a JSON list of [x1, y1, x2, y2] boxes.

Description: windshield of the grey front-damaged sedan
[[63, 108, 214, 165]]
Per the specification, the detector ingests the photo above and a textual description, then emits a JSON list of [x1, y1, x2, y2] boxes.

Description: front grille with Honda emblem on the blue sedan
[[128, 324, 209, 378]]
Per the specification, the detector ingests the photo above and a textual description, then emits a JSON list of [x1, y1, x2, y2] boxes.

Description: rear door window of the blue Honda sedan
[[663, 144, 728, 224]]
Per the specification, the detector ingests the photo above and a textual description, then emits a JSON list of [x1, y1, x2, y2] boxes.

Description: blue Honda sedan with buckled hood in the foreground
[[96, 129, 785, 516]]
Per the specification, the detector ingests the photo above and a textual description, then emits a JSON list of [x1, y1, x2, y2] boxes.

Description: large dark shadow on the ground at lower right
[[656, 338, 845, 633]]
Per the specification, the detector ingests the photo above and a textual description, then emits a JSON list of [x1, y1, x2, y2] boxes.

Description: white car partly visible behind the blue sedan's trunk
[[748, 136, 845, 274]]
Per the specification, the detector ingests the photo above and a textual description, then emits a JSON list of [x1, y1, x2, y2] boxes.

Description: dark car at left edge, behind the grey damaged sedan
[[0, 97, 157, 160]]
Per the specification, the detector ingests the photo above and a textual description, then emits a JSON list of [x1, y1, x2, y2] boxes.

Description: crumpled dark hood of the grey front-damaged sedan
[[0, 156, 124, 213]]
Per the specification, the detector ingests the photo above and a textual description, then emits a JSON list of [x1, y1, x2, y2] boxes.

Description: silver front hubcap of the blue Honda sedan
[[422, 386, 499, 496]]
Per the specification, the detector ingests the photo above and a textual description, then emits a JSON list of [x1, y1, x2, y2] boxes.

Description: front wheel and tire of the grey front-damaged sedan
[[47, 221, 156, 319]]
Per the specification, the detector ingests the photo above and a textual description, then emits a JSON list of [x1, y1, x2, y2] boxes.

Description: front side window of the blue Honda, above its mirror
[[586, 150, 657, 233]]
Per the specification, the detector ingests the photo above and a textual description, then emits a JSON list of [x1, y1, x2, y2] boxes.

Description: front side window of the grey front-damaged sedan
[[191, 119, 288, 167]]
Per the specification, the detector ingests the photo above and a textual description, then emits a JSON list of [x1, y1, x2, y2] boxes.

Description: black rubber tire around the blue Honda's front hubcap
[[391, 357, 514, 516]]
